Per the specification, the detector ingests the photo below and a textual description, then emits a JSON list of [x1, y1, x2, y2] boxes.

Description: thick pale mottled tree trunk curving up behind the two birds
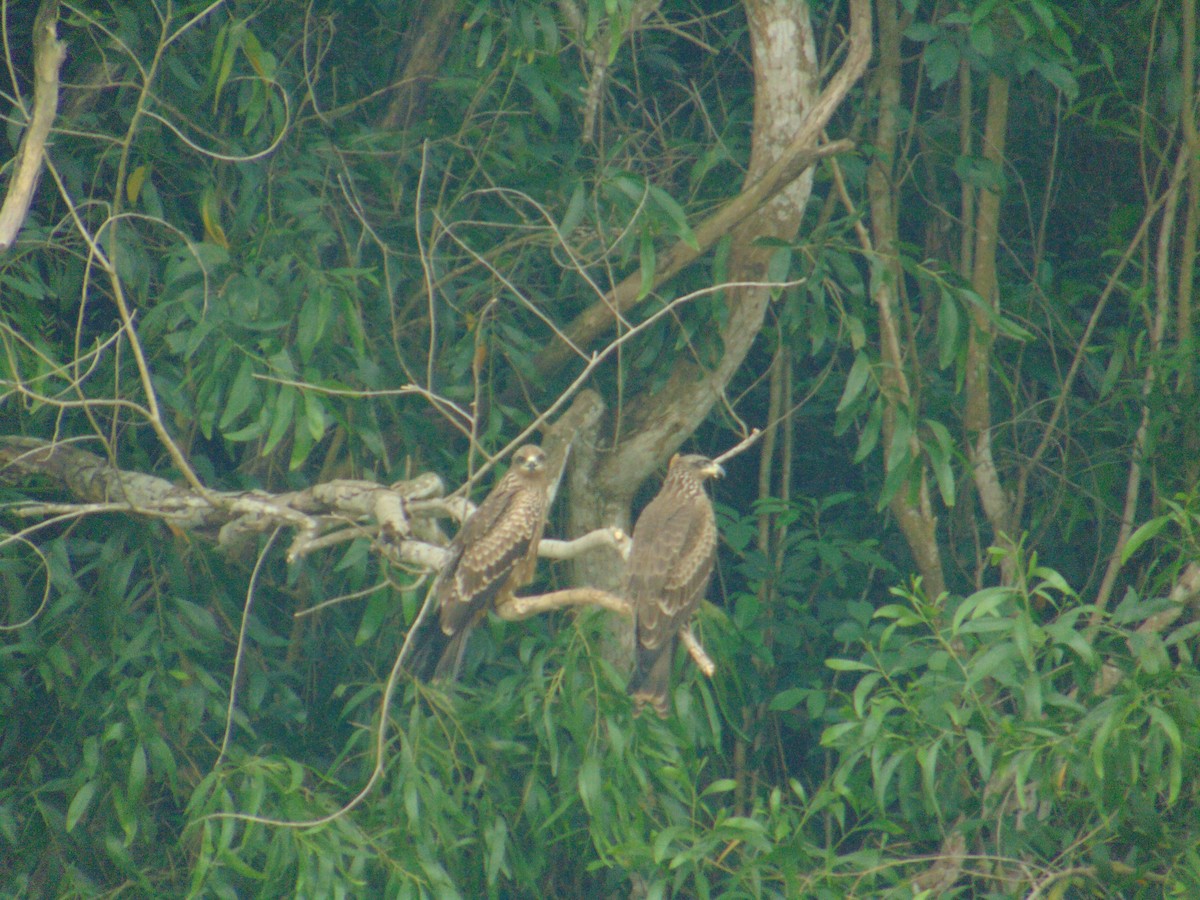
[[570, 0, 871, 662]]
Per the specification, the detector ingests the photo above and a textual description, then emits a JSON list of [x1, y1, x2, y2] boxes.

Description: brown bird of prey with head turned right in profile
[[626, 454, 725, 716]]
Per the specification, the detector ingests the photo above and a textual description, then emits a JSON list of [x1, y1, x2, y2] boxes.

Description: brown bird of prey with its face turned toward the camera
[[404, 445, 548, 682]]
